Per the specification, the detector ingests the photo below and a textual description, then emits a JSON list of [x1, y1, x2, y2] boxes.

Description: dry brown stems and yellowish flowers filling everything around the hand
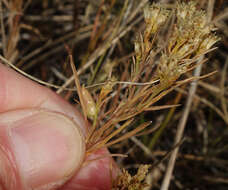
[[0, 0, 228, 190]]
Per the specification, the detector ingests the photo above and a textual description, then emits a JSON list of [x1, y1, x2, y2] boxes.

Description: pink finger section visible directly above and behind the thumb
[[0, 63, 86, 132]]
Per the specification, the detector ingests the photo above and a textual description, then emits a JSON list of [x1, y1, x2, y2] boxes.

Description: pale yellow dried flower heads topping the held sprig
[[139, 2, 219, 83]]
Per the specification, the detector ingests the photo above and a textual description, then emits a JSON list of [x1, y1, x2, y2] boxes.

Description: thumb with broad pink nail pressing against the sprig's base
[[0, 109, 85, 190]]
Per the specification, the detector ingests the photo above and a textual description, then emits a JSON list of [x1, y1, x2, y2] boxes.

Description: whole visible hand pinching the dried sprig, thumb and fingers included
[[0, 64, 115, 190]]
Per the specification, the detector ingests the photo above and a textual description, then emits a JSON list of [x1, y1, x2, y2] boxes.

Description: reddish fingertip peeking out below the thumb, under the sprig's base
[[61, 149, 119, 190]]
